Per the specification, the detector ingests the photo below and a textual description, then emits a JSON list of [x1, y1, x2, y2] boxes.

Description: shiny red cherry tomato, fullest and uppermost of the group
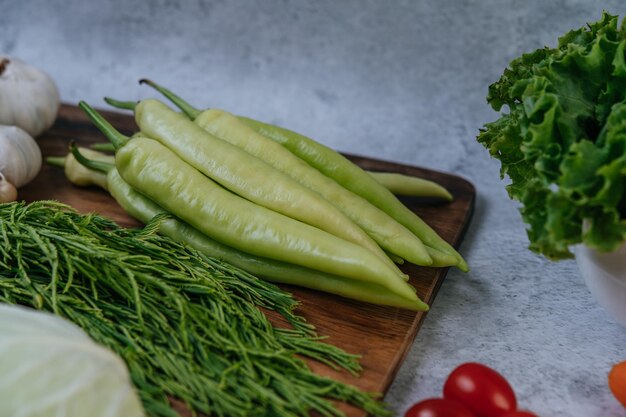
[[443, 362, 517, 417]]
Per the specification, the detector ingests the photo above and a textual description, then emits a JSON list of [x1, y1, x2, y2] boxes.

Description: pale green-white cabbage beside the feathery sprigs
[[0, 304, 144, 417]]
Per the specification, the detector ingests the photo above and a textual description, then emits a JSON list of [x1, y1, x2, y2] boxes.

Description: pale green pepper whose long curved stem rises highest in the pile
[[135, 80, 433, 265]]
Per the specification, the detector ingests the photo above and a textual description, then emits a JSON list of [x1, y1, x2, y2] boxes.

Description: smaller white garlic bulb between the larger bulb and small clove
[[0, 125, 41, 188]]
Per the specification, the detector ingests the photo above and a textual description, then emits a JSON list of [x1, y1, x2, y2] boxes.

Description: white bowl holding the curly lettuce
[[574, 244, 626, 326]]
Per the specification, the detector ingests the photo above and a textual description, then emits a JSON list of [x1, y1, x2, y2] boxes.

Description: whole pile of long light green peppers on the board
[[48, 80, 467, 311]]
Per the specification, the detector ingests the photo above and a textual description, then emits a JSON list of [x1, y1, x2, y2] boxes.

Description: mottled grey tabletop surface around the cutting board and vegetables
[[0, 0, 626, 417]]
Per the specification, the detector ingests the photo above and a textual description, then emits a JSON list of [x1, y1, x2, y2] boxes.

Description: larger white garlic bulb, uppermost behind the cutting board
[[0, 55, 60, 137]]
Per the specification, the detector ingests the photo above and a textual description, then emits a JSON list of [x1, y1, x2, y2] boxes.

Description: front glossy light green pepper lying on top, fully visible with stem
[[80, 102, 418, 301]]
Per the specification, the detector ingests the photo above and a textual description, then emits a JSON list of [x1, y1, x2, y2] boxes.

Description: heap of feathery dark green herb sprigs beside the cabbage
[[0, 201, 387, 417]]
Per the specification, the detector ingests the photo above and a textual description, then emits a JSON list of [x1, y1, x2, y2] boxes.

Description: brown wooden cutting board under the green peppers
[[20, 105, 475, 417]]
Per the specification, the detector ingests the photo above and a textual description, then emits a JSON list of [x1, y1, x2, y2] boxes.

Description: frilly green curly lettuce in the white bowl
[[477, 13, 626, 260]]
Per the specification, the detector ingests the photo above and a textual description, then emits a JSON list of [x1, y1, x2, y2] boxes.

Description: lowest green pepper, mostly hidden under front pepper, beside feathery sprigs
[[61, 146, 428, 311]]
